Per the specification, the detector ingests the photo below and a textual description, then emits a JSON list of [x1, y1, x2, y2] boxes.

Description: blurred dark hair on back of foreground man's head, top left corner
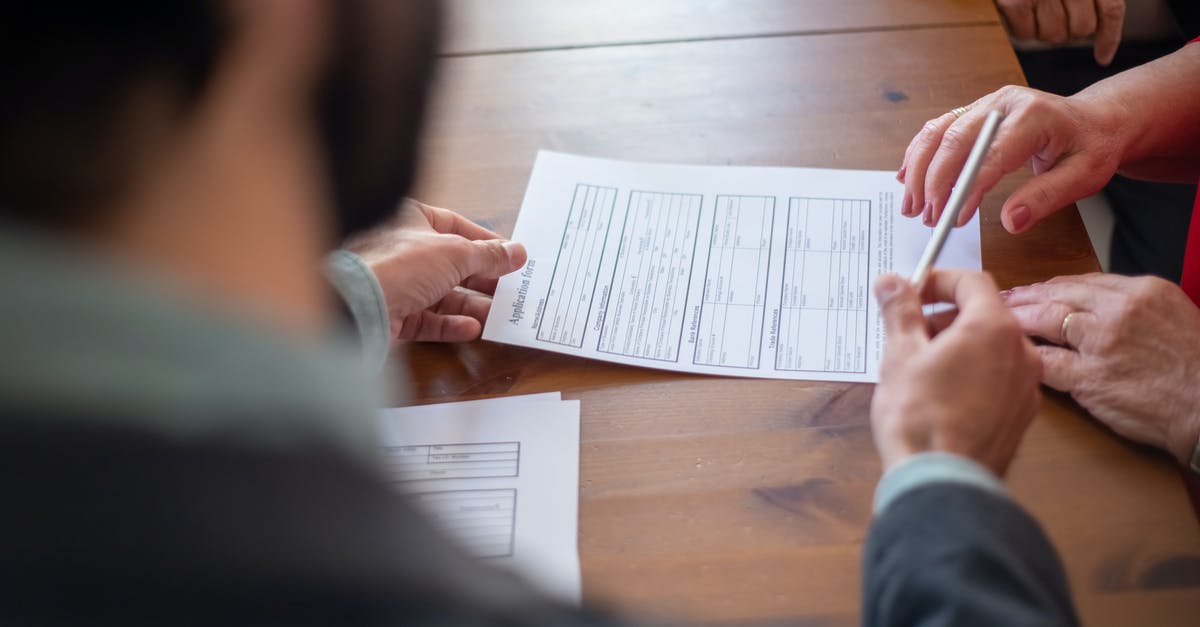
[[0, 0, 227, 222]]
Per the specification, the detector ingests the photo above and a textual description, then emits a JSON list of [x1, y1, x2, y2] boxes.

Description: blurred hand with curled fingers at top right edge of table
[[996, 0, 1126, 66]]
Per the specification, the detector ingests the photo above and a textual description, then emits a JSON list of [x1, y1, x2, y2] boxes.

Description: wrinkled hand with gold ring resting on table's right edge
[[1006, 274, 1200, 462]]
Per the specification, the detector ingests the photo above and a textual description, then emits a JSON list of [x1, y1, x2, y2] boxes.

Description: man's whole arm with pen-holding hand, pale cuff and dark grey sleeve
[[863, 271, 1078, 626]]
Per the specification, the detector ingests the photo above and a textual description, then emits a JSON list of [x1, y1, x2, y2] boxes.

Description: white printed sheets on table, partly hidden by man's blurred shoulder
[[380, 393, 581, 604]]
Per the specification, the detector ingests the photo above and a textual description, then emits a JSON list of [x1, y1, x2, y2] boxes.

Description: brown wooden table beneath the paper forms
[[404, 0, 1200, 625]]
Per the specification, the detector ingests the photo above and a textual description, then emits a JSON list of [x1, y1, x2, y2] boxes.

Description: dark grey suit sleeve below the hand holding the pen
[[863, 482, 1079, 627]]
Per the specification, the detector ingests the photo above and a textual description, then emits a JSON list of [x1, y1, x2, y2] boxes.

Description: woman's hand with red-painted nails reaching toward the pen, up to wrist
[[896, 86, 1128, 233]]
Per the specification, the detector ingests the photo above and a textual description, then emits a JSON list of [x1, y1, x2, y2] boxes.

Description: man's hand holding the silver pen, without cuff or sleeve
[[871, 270, 1042, 476]]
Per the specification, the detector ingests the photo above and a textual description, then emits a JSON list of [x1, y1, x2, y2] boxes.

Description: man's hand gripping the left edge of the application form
[[346, 201, 526, 342]]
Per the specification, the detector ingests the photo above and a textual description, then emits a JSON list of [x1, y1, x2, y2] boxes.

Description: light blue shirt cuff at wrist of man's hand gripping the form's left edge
[[325, 250, 391, 372]]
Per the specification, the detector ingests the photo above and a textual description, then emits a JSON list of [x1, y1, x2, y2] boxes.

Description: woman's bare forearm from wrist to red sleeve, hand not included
[[1073, 44, 1200, 183]]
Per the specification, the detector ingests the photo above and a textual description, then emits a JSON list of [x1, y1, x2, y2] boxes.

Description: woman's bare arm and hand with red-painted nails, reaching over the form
[[898, 39, 1200, 233]]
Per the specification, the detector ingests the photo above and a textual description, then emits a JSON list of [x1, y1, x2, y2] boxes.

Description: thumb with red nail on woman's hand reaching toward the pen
[[1000, 155, 1104, 234]]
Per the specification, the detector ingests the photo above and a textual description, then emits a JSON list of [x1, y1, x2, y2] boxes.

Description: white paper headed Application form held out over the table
[[484, 151, 980, 382]]
